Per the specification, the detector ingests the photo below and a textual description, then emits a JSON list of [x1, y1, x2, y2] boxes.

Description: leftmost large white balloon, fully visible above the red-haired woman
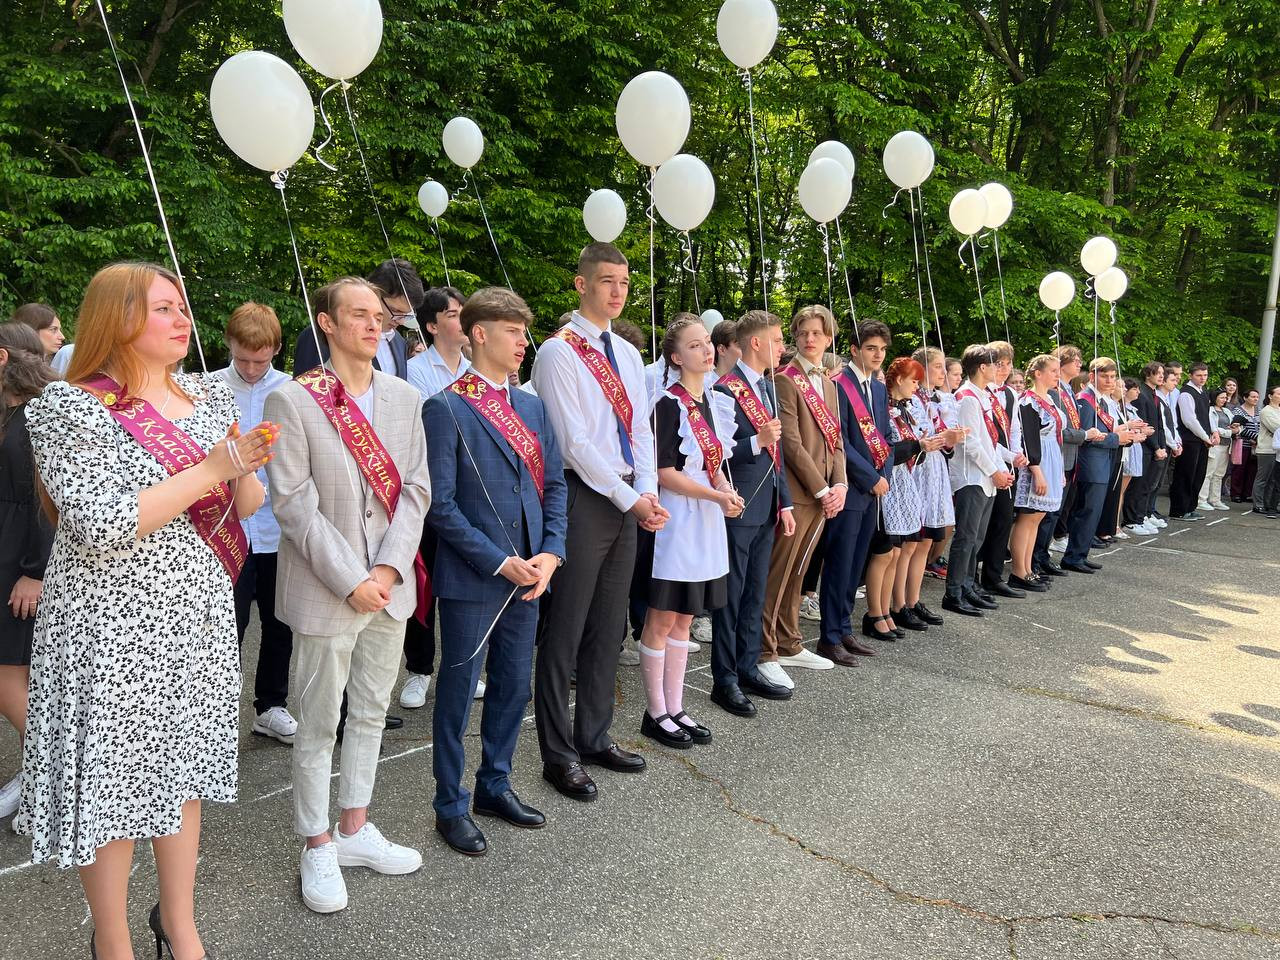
[[209, 50, 316, 172]]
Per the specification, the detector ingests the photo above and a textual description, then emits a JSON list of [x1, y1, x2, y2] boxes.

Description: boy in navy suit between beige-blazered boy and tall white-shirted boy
[[422, 287, 568, 856]]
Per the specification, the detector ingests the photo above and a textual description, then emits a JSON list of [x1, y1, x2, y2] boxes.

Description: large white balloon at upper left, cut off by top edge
[[283, 0, 383, 79]]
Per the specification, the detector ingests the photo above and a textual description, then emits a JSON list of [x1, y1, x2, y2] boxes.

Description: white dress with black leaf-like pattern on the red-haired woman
[[15, 374, 241, 867]]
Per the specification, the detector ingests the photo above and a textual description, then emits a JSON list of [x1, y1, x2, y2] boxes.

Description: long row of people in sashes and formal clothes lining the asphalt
[[0, 243, 1280, 960]]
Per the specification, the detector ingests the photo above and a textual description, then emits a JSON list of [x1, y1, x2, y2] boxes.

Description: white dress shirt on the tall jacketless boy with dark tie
[[532, 311, 658, 511]]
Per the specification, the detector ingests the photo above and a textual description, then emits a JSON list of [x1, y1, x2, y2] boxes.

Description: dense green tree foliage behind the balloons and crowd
[[0, 0, 1280, 371]]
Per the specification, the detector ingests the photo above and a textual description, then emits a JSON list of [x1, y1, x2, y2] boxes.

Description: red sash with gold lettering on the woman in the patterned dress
[[81, 374, 248, 584]]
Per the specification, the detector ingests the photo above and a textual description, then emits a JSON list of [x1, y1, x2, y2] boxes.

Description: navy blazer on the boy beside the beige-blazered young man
[[422, 389, 568, 603]]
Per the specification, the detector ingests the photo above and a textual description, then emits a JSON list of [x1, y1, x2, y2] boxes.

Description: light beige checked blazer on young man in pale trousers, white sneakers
[[262, 370, 431, 636]]
